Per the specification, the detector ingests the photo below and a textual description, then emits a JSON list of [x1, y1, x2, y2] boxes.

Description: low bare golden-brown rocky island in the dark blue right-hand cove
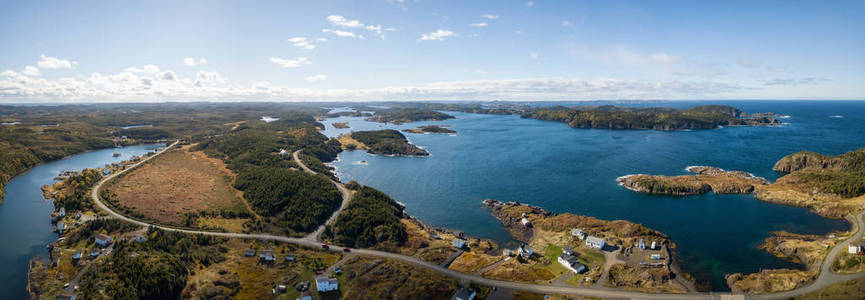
[[616, 166, 769, 196]]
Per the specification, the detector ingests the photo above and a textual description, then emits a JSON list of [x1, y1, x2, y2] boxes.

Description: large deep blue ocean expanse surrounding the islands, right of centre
[[323, 101, 865, 291]]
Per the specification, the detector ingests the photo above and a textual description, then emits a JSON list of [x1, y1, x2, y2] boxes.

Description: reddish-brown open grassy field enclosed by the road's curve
[[107, 150, 249, 225]]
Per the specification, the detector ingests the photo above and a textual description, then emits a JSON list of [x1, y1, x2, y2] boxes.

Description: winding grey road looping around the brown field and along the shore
[[91, 141, 865, 299]]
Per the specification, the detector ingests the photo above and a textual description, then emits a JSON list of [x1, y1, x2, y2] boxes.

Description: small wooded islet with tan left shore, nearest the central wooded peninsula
[[339, 129, 429, 156]]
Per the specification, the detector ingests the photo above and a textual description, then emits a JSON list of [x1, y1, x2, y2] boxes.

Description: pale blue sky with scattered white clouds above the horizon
[[0, 0, 865, 104]]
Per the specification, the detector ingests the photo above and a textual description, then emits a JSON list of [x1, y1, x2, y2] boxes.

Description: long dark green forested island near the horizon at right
[[521, 105, 781, 131]]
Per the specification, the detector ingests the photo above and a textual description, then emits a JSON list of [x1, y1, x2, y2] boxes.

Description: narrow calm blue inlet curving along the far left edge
[[0, 144, 164, 299]]
